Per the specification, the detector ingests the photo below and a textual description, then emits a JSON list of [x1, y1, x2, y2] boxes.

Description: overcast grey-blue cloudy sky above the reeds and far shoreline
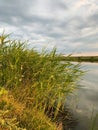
[[0, 0, 98, 54]]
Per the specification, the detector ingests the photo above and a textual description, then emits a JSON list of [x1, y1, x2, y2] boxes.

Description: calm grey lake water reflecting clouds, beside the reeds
[[68, 63, 98, 130]]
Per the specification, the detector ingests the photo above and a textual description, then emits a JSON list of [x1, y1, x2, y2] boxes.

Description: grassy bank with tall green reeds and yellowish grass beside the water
[[0, 34, 82, 130]]
